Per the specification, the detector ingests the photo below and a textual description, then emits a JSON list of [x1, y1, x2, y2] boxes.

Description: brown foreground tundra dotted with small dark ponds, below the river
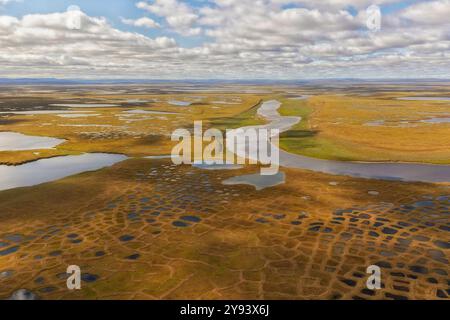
[[0, 160, 450, 299]]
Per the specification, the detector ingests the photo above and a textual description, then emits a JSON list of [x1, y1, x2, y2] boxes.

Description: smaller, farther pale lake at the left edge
[[0, 132, 66, 151]]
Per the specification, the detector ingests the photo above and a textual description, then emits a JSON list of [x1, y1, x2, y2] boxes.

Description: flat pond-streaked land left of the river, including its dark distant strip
[[0, 89, 261, 164]]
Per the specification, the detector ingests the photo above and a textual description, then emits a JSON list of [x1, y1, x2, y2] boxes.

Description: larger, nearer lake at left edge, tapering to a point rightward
[[0, 153, 127, 190]]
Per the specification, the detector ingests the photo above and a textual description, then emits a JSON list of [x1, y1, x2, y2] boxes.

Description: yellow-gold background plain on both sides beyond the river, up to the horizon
[[0, 85, 450, 164]]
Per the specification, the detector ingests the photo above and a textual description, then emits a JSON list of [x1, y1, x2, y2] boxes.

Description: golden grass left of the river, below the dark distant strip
[[0, 94, 260, 164]]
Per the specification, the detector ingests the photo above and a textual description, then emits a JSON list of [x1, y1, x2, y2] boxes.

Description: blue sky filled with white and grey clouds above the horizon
[[0, 0, 450, 80]]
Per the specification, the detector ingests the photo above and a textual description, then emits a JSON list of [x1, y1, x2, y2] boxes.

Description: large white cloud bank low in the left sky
[[0, 12, 177, 76]]
